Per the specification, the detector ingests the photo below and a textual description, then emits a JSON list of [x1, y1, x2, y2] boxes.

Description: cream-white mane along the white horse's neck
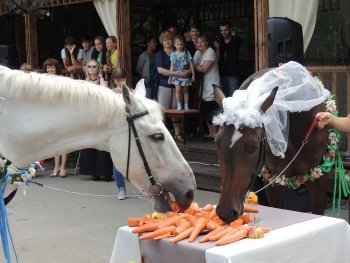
[[0, 66, 161, 124]]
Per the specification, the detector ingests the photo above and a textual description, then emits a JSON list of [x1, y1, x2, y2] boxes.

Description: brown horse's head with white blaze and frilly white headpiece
[[214, 85, 277, 223]]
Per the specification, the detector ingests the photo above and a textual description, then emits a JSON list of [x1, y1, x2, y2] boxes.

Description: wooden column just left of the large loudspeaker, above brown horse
[[254, 0, 269, 71]]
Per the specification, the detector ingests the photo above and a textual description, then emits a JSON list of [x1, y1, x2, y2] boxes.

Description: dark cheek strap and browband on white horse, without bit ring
[[126, 107, 156, 185]]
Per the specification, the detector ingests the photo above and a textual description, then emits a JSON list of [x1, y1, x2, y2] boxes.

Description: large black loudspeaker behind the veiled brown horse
[[267, 17, 304, 67]]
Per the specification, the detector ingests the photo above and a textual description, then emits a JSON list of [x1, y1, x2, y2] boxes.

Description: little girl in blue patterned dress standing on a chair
[[168, 35, 195, 111]]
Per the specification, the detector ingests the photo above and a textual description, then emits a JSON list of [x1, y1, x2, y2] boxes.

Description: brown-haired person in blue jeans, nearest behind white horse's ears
[[111, 68, 130, 200]]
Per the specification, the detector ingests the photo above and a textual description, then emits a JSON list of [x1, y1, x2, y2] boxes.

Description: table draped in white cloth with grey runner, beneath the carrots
[[110, 206, 350, 263]]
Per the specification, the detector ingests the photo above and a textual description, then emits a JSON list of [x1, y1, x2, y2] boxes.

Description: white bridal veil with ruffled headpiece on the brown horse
[[213, 61, 330, 158]]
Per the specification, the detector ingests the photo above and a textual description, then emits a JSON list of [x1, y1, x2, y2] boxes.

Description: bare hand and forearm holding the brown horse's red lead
[[316, 112, 350, 132]]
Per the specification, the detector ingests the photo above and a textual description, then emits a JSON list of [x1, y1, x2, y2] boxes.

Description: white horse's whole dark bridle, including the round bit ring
[[126, 107, 164, 196]]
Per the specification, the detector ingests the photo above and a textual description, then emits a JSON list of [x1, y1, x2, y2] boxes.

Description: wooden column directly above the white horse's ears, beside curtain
[[115, 0, 132, 87]]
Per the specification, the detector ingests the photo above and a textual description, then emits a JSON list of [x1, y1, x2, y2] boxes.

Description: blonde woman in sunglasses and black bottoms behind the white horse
[[79, 59, 113, 182]]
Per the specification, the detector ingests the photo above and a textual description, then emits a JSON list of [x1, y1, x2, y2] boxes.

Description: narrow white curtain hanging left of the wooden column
[[94, 0, 117, 36]]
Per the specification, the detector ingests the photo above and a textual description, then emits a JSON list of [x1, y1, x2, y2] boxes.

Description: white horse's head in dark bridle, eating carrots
[[110, 81, 196, 212]]
